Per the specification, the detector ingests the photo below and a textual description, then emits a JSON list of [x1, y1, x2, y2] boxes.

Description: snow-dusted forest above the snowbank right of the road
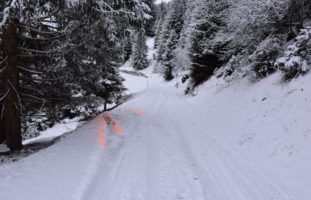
[[155, 0, 311, 89]]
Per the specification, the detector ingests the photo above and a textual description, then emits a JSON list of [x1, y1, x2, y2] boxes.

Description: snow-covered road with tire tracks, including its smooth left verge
[[0, 82, 290, 200]]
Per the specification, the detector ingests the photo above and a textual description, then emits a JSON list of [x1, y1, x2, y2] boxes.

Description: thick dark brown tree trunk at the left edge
[[3, 19, 22, 151]]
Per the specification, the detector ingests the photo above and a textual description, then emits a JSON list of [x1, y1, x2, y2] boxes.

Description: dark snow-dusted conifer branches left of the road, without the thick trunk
[[0, 0, 147, 145]]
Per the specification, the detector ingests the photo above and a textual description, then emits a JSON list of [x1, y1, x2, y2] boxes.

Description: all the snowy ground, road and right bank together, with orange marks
[[0, 38, 311, 200]]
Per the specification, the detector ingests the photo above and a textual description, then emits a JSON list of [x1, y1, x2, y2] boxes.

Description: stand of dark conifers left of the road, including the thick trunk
[[0, 0, 147, 150]]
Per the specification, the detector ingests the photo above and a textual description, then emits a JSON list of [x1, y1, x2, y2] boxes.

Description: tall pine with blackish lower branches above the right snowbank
[[189, 0, 228, 87]]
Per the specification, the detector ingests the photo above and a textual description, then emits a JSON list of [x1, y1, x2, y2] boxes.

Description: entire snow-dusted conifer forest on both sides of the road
[[0, 0, 311, 150]]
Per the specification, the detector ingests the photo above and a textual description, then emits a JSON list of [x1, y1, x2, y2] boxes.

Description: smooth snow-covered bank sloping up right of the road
[[188, 73, 311, 200]]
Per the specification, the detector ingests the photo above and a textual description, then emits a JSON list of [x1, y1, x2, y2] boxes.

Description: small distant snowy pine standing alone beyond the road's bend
[[132, 30, 148, 70]]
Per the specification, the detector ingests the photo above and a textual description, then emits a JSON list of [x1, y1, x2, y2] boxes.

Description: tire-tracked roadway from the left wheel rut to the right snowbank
[[85, 84, 290, 200]]
